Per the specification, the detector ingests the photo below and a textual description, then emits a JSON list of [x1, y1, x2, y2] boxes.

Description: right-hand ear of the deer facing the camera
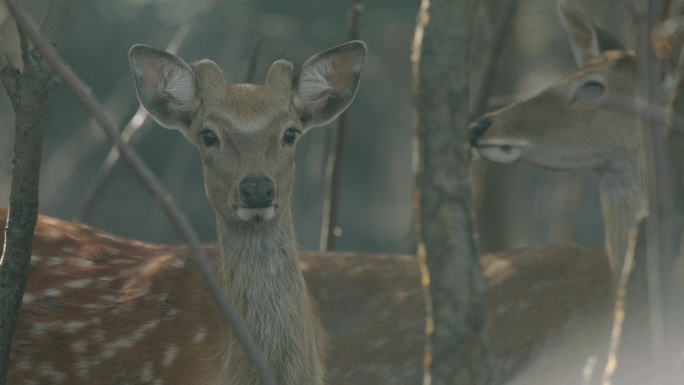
[[293, 41, 366, 129]]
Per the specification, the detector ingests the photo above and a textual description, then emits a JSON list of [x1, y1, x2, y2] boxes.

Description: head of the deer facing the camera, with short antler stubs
[[129, 41, 366, 221]]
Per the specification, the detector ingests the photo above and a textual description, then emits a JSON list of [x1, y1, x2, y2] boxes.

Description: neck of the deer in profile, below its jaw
[[600, 159, 648, 278]]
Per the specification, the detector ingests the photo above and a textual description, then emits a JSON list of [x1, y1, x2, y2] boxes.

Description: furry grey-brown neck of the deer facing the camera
[[217, 210, 322, 385]]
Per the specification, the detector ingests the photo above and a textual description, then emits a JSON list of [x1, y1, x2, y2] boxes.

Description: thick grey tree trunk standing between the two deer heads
[[411, 0, 489, 385]]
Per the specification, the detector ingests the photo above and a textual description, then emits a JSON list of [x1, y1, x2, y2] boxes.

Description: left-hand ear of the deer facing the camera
[[128, 45, 200, 131]]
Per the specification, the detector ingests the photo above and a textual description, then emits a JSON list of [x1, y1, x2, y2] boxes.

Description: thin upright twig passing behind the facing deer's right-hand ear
[[318, 0, 363, 252]]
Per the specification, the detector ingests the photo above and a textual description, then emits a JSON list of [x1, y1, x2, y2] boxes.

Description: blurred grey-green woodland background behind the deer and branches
[[0, 0, 634, 253]]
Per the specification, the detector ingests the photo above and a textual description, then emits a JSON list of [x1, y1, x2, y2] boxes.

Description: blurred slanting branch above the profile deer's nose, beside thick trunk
[[470, 0, 518, 120]]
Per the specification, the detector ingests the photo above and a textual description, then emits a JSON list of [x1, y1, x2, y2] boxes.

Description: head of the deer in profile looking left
[[470, 0, 640, 171]]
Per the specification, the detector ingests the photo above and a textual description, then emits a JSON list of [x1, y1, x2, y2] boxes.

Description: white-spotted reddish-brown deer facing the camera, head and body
[[8, 41, 366, 385]]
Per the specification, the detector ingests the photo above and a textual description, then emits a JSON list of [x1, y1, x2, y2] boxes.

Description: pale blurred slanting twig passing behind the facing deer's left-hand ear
[[74, 12, 203, 222]]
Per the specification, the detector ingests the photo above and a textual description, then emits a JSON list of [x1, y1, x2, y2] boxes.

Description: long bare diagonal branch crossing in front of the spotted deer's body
[[5, 0, 276, 385]]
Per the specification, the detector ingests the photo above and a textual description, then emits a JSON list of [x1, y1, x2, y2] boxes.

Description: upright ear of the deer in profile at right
[[558, 0, 625, 67]]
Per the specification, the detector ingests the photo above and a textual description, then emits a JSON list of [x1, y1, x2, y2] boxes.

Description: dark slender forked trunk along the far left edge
[[0, 0, 68, 384]]
